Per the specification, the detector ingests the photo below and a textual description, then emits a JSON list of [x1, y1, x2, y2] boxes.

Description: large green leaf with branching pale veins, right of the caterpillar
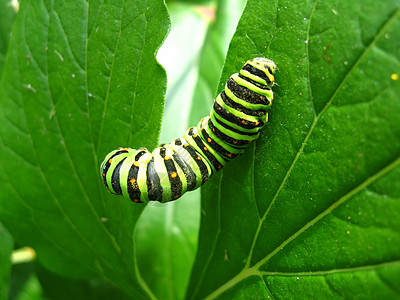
[[187, 0, 400, 299]]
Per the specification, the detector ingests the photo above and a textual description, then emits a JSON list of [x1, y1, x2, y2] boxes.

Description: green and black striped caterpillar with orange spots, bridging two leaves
[[100, 57, 277, 203]]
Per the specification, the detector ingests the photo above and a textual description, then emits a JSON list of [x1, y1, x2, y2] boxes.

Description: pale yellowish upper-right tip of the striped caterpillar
[[239, 57, 277, 87]]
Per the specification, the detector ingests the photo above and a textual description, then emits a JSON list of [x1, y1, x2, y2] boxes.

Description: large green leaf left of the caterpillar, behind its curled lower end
[[0, 0, 169, 299]]
